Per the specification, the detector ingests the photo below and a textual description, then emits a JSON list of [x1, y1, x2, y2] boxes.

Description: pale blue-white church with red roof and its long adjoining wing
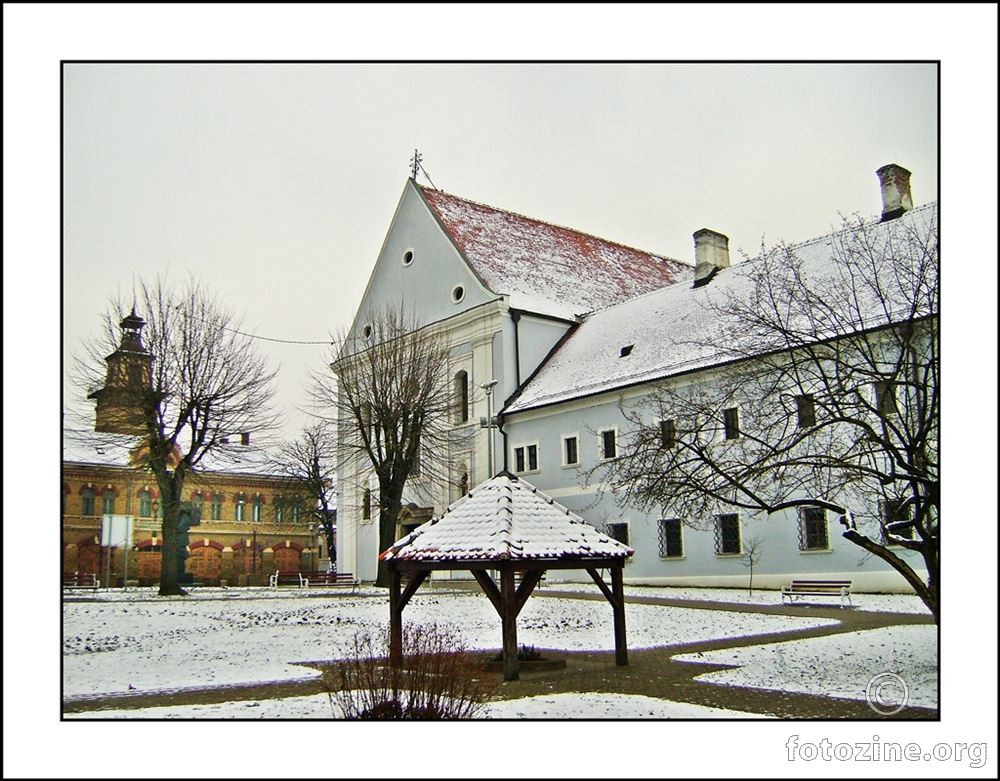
[[338, 166, 937, 591]]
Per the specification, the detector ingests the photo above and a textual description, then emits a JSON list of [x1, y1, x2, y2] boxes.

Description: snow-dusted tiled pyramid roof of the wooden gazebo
[[381, 473, 633, 561]]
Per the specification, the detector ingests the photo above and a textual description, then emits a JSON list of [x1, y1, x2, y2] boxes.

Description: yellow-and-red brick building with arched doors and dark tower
[[62, 311, 318, 585]]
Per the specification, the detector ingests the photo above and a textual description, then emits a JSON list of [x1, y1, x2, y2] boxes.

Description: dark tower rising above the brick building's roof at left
[[87, 306, 153, 434]]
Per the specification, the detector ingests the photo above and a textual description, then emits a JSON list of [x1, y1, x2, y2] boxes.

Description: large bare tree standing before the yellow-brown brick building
[[73, 278, 278, 596]]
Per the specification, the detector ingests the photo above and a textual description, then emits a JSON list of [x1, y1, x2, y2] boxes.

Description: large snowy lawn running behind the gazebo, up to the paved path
[[63, 587, 837, 698]]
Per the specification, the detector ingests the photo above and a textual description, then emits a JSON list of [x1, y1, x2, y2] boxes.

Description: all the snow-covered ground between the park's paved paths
[[62, 584, 937, 719]]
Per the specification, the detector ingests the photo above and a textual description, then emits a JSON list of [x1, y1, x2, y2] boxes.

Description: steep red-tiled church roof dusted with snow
[[421, 187, 691, 319]]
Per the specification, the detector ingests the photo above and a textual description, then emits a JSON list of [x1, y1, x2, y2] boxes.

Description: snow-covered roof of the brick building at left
[[62, 429, 278, 477]]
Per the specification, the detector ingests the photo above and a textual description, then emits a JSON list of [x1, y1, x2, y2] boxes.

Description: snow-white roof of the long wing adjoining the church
[[504, 204, 937, 414]]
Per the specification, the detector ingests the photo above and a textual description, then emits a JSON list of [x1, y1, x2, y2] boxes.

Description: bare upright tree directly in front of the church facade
[[322, 306, 456, 586]]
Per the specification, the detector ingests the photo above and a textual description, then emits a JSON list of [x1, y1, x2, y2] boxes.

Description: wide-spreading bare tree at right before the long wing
[[592, 209, 940, 619]]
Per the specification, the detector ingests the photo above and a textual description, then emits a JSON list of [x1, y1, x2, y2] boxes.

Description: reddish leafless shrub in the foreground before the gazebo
[[326, 624, 496, 720]]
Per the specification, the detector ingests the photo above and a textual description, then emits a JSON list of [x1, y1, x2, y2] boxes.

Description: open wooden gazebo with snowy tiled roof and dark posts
[[380, 472, 633, 681]]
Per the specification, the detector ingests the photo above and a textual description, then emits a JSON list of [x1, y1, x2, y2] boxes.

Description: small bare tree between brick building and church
[[278, 420, 337, 561]]
